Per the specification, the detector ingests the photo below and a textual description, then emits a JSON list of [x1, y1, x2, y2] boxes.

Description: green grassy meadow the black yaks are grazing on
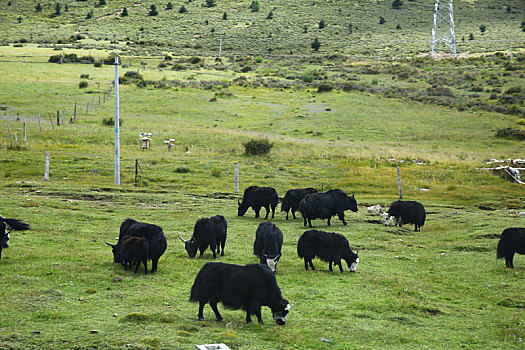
[[0, 42, 525, 349]]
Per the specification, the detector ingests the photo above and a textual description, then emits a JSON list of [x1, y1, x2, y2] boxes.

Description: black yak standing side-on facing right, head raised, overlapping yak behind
[[299, 189, 357, 227]]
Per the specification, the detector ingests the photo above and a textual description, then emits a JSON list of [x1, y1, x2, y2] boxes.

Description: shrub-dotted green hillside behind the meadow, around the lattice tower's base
[[0, 0, 525, 57]]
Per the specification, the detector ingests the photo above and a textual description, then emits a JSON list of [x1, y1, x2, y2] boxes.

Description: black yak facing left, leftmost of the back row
[[237, 186, 279, 219]]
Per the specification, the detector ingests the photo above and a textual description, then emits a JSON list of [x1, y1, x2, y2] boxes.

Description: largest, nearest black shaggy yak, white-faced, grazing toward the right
[[190, 262, 290, 325]]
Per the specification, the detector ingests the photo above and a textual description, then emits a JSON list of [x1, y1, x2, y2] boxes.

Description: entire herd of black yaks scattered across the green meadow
[[0, 186, 525, 325]]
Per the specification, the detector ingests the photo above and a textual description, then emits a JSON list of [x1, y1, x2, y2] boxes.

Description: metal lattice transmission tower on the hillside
[[432, 0, 456, 57]]
